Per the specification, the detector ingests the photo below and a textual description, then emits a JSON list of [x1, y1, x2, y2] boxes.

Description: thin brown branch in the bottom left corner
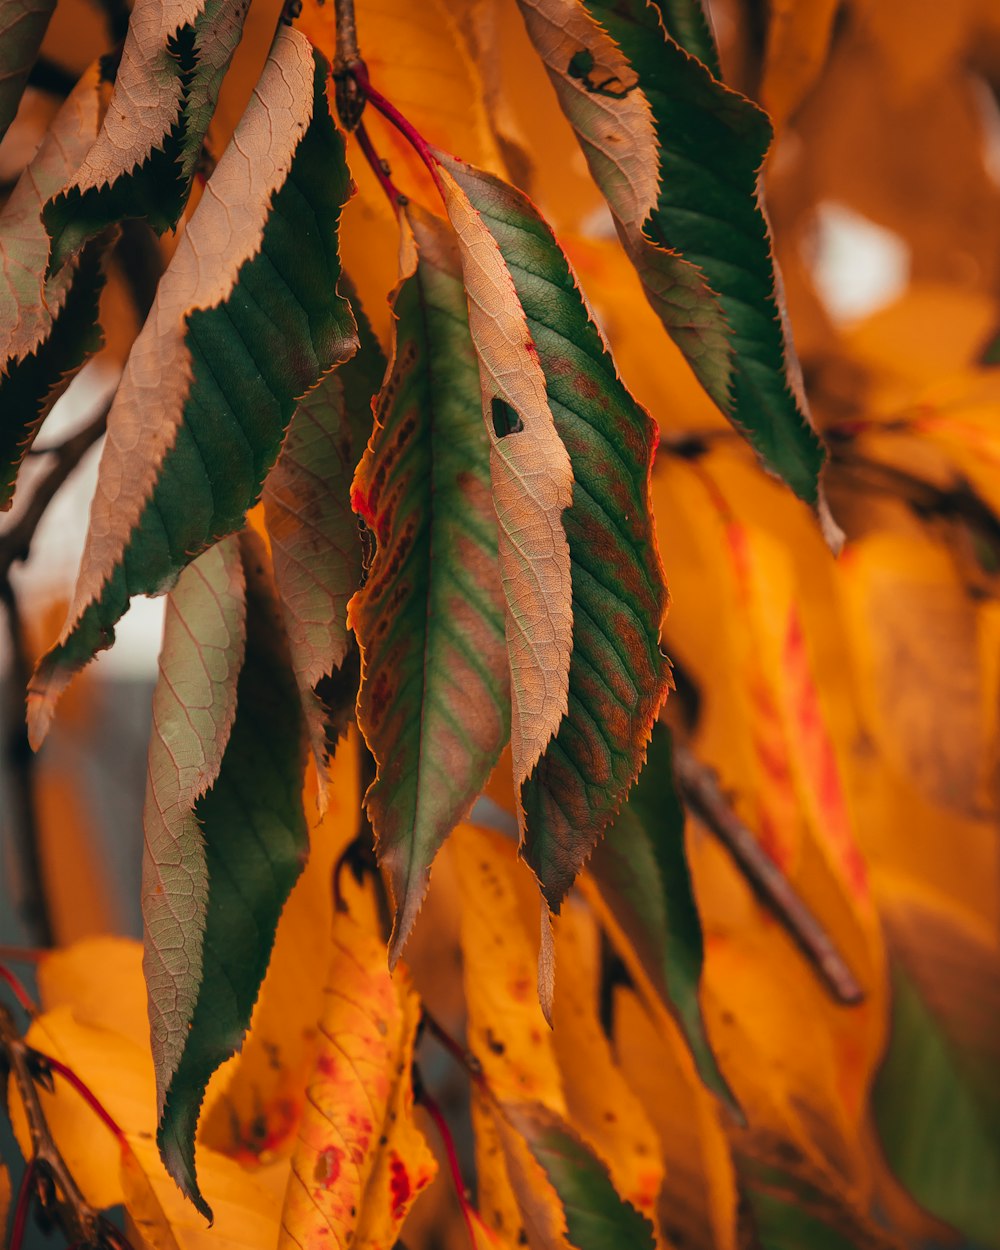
[[0, 1005, 129, 1250]]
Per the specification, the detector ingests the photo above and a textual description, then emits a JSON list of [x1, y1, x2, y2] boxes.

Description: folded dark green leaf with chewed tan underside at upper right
[[520, 0, 838, 522]]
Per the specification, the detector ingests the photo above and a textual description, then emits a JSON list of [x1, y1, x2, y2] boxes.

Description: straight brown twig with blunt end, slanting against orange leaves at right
[[674, 743, 865, 1005]]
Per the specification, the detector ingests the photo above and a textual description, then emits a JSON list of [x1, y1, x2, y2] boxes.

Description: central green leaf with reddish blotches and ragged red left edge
[[349, 209, 510, 964]]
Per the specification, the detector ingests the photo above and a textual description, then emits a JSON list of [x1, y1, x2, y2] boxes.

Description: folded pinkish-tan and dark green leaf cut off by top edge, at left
[[45, 0, 250, 271]]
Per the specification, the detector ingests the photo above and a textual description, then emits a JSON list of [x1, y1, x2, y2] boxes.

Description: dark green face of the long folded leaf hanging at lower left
[[146, 534, 309, 1218]]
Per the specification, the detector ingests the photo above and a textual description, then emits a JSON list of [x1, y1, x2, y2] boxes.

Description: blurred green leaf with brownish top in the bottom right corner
[[873, 900, 1000, 1246]]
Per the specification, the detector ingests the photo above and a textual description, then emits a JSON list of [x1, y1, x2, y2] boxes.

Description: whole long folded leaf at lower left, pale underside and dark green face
[[143, 534, 309, 1219]]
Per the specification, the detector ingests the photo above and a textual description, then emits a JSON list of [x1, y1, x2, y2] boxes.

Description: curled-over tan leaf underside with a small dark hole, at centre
[[440, 158, 573, 800]]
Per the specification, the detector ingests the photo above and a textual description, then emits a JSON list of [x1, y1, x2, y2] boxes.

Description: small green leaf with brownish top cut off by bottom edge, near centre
[[500, 1104, 655, 1250]]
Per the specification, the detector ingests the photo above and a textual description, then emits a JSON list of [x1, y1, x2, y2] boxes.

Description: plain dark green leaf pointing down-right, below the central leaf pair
[[589, 723, 734, 1106]]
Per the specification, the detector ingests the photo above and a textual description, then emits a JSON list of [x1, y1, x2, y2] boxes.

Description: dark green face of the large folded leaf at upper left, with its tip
[[29, 36, 356, 743]]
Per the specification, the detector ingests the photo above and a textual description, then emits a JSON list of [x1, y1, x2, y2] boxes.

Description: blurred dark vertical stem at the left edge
[[0, 585, 55, 946]]
